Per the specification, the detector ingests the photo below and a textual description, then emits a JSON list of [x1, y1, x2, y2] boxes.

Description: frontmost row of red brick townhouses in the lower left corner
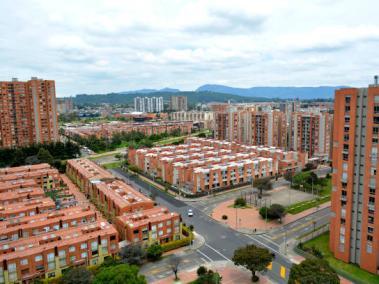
[[0, 221, 118, 283]]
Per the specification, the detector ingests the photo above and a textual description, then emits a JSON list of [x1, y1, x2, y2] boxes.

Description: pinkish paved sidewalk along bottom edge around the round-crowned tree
[[152, 261, 271, 284]]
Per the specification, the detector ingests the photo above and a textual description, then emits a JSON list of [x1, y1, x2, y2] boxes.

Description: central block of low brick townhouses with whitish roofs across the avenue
[[128, 138, 307, 194]]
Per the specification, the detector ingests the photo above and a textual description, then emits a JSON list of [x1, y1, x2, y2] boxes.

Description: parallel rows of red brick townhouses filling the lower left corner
[[0, 164, 118, 283]]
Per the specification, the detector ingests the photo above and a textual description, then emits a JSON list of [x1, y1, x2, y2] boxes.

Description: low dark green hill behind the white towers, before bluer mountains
[[74, 91, 268, 105]]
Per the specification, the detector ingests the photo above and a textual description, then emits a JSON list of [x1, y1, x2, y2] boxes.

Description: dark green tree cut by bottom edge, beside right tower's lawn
[[288, 259, 340, 284]]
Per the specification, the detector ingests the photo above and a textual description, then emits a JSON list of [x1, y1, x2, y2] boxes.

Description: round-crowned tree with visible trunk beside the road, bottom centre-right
[[233, 245, 274, 282]]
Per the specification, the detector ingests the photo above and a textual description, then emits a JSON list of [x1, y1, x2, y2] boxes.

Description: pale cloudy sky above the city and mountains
[[0, 0, 379, 97]]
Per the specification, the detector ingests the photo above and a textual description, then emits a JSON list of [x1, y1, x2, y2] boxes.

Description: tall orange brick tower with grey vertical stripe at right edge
[[329, 77, 379, 274]]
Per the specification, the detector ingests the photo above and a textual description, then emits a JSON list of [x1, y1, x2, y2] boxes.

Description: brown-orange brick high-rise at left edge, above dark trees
[[0, 77, 59, 147]]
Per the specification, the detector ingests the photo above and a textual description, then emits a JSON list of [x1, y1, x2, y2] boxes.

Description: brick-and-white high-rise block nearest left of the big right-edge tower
[[289, 111, 333, 160]]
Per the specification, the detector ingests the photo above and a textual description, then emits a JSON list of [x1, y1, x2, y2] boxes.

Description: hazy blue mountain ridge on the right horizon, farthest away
[[196, 85, 342, 100]]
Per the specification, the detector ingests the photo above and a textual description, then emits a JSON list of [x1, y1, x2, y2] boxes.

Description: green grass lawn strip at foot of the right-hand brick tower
[[304, 232, 379, 284]]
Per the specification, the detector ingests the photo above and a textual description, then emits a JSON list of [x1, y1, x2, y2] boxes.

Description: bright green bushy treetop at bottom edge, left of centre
[[93, 264, 147, 284]]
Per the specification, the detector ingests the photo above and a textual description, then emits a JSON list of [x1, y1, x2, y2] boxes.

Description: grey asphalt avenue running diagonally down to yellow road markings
[[112, 169, 292, 283]]
